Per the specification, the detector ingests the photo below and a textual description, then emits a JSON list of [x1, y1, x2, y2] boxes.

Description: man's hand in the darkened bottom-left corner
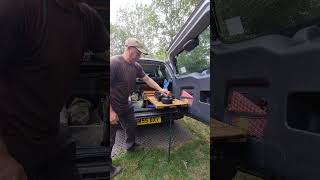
[[0, 153, 27, 180]]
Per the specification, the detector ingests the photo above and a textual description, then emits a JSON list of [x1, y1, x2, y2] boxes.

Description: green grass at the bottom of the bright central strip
[[113, 117, 210, 180]]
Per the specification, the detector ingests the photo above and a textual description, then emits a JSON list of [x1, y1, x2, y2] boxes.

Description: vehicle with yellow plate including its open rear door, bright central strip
[[131, 1, 210, 125]]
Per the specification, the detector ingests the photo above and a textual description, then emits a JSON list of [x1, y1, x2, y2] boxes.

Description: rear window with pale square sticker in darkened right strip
[[214, 0, 320, 42]]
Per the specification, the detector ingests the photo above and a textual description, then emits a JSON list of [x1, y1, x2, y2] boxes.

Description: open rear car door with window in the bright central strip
[[168, 0, 210, 123]]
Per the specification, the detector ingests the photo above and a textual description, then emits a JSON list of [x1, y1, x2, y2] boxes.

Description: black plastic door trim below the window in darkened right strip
[[211, 27, 320, 179]]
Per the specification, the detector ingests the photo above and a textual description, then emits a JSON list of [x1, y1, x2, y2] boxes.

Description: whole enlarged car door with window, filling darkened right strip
[[212, 0, 320, 179]]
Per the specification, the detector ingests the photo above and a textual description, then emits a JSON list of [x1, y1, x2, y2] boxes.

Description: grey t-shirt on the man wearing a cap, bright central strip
[[110, 56, 145, 114]]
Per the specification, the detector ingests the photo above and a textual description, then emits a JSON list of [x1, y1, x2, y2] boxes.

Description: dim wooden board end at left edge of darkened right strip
[[210, 119, 247, 144]]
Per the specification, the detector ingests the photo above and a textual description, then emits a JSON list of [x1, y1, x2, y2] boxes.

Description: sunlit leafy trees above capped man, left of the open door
[[110, 0, 200, 59]]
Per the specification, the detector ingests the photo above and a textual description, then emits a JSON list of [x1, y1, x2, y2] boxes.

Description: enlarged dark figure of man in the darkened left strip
[[0, 0, 108, 180]]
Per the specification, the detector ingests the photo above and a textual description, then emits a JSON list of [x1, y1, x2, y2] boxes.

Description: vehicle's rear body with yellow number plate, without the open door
[[130, 58, 187, 125]]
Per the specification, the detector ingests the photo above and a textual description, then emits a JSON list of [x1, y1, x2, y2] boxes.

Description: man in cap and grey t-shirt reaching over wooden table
[[110, 38, 169, 176]]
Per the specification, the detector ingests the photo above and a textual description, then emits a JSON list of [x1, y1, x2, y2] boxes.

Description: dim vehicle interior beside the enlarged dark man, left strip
[[60, 0, 110, 180]]
